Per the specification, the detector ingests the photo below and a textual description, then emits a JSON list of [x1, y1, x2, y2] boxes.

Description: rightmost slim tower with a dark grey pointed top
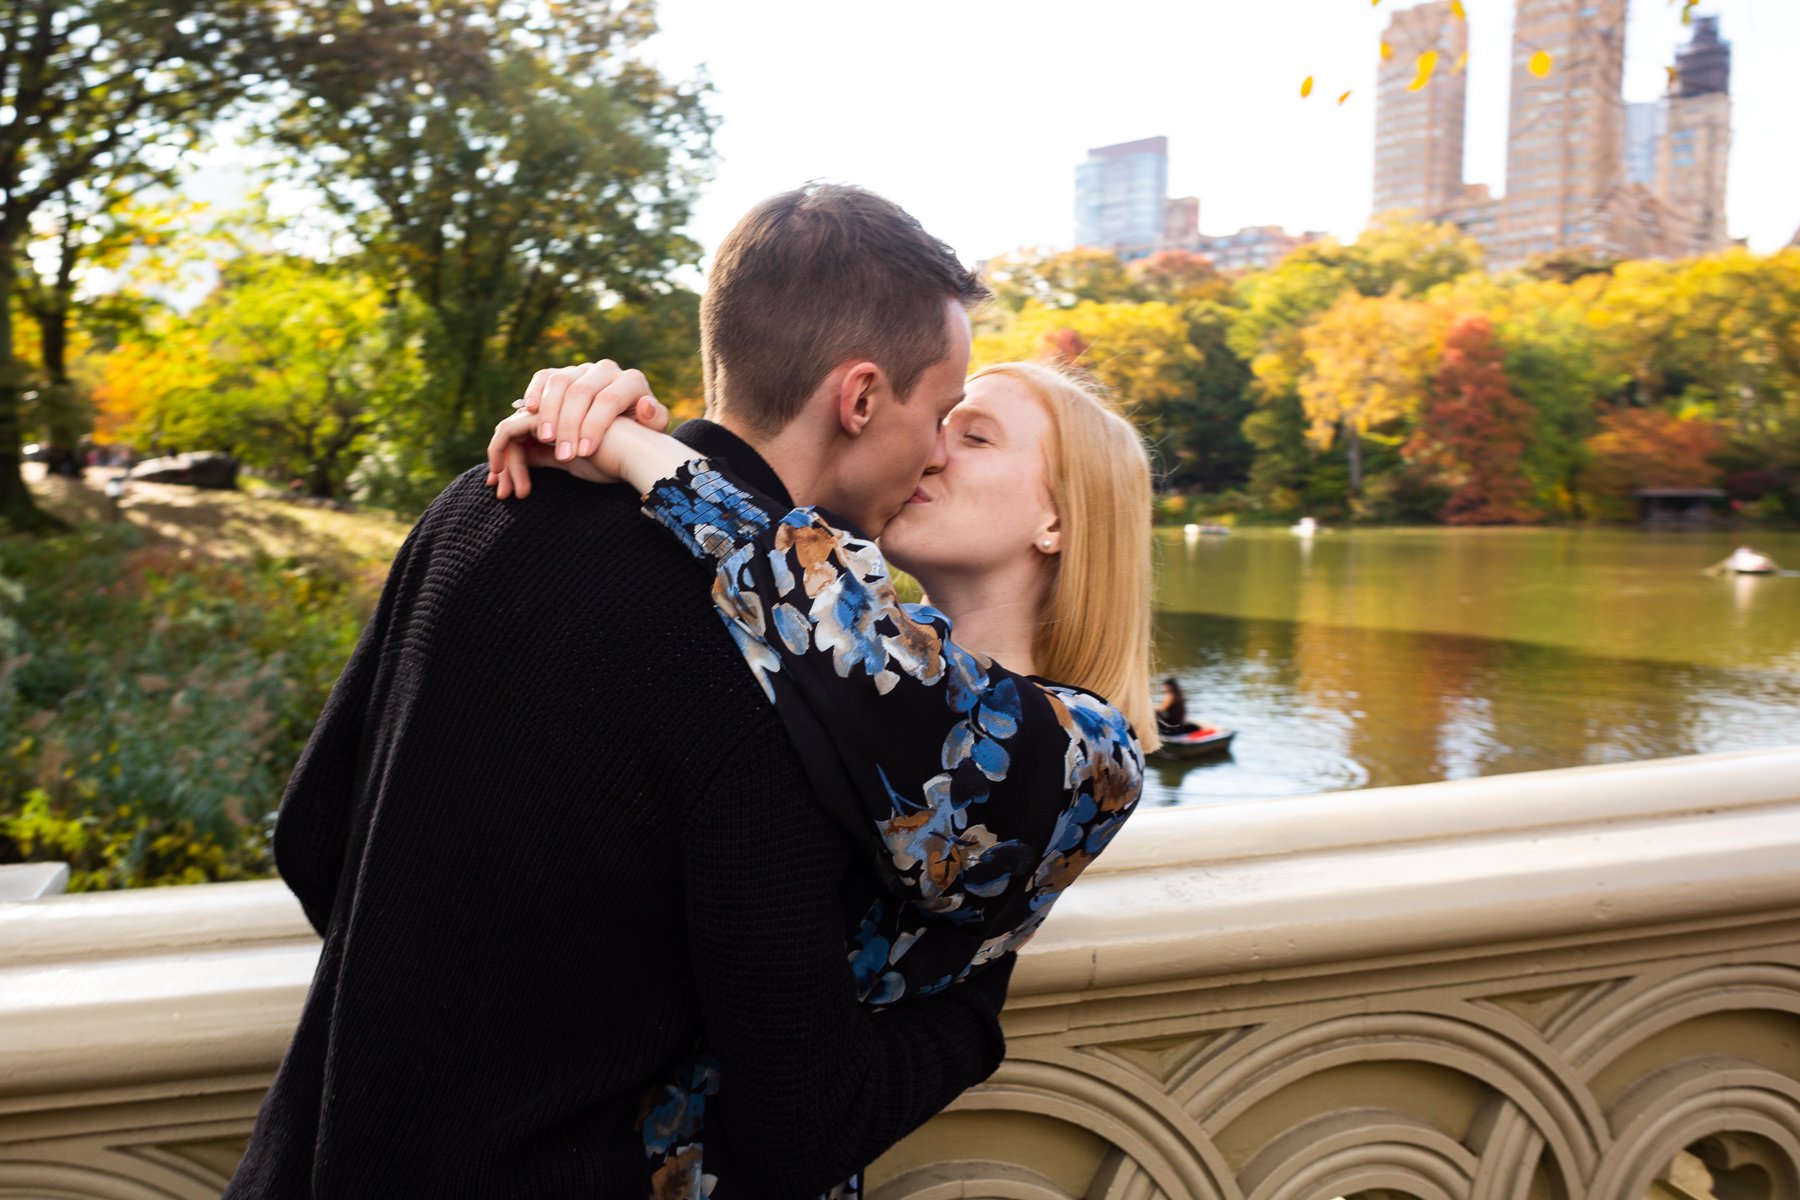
[[1656, 16, 1732, 254]]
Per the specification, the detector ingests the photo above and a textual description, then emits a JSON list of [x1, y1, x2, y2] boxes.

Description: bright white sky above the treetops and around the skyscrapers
[[650, 0, 1800, 261]]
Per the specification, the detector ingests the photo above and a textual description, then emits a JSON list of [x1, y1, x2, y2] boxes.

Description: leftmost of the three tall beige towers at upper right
[[1373, 0, 1469, 219]]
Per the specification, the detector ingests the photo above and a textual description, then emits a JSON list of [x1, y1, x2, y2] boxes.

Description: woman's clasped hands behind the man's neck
[[488, 360, 670, 500]]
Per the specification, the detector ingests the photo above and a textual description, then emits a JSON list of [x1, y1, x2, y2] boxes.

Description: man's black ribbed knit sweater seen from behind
[[225, 421, 1006, 1200]]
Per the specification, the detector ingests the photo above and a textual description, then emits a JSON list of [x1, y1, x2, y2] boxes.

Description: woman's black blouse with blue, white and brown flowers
[[641, 459, 1143, 1200]]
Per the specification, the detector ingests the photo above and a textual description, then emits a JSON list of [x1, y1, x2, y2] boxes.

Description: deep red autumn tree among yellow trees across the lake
[[1404, 315, 1537, 525]]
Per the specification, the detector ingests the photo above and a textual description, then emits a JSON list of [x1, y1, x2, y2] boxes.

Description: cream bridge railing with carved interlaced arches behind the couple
[[0, 748, 1800, 1200]]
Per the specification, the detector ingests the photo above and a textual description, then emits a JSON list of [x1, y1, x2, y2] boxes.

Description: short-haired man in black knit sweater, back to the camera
[[225, 187, 1148, 1200]]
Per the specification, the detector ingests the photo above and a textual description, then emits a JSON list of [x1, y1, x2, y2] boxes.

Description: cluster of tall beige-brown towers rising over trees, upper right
[[1373, 0, 1732, 270]]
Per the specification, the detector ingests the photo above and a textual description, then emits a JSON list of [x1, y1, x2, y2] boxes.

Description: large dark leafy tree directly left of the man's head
[[275, 0, 713, 473]]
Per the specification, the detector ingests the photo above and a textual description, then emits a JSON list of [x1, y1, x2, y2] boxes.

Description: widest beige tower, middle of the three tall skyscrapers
[[1489, 0, 1634, 268]]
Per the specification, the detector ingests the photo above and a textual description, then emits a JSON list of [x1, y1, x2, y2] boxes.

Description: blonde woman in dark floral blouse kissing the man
[[490, 363, 1156, 1200]]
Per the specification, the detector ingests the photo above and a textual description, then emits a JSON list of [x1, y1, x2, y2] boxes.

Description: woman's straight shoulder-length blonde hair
[[970, 362, 1161, 750]]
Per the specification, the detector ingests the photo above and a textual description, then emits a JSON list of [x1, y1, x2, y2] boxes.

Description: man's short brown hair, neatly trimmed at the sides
[[700, 184, 988, 435]]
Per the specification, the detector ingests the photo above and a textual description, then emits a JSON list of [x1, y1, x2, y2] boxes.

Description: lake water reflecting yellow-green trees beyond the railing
[[1145, 529, 1800, 804]]
